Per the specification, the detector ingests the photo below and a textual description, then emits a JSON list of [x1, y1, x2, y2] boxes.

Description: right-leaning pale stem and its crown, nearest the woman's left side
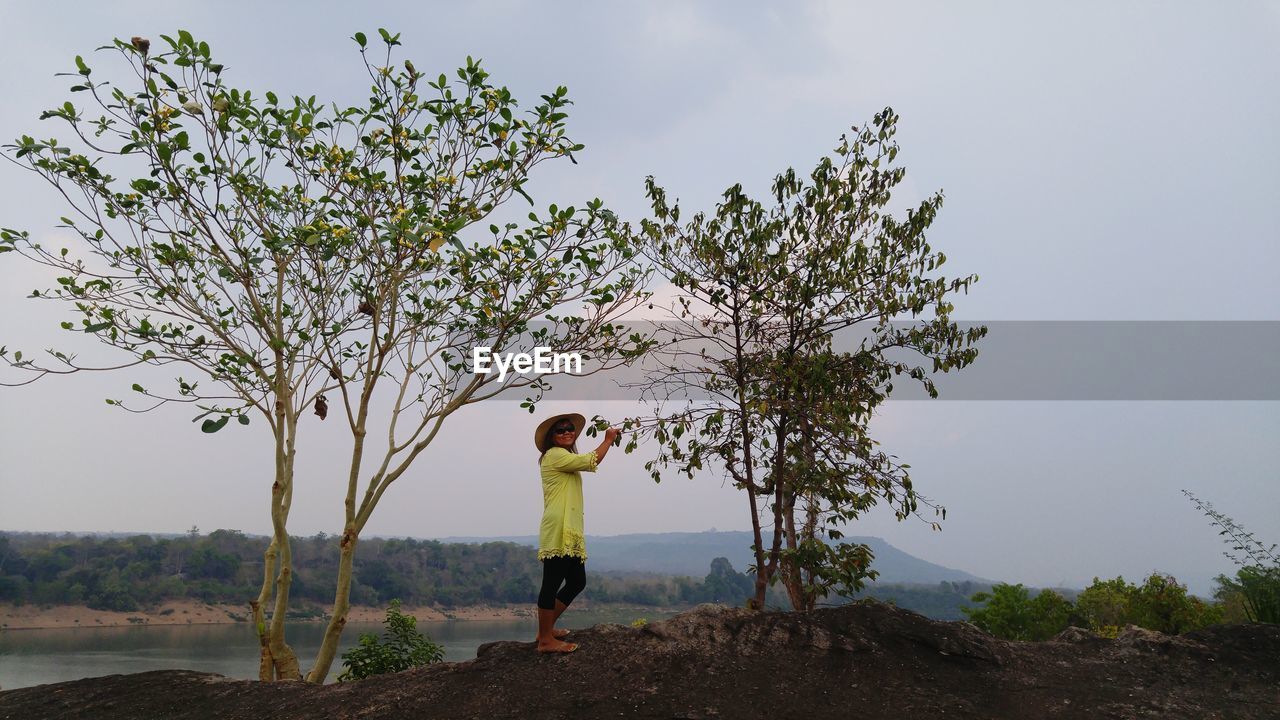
[[285, 32, 652, 682]]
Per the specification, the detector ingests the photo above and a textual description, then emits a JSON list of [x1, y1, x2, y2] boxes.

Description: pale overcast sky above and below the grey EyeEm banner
[[0, 1, 1280, 592]]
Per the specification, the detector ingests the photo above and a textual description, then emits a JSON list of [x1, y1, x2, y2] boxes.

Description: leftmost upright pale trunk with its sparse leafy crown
[[0, 31, 378, 679]]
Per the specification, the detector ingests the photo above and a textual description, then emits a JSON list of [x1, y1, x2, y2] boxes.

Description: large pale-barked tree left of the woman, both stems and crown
[[0, 29, 646, 682]]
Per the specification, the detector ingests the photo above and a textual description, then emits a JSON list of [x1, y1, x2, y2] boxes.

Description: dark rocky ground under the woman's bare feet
[[0, 602, 1280, 720]]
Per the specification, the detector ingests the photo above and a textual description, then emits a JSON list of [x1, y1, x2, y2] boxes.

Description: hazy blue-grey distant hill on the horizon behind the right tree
[[436, 530, 989, 584]]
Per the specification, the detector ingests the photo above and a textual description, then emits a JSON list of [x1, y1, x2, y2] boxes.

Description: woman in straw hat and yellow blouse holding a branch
[[534, 413, 621, 652]]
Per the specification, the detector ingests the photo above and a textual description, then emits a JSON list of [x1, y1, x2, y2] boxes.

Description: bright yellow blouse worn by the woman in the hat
[[538, 446, 598, 560]]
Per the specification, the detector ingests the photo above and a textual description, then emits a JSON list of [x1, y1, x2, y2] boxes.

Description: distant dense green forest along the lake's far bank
[[0, 530, 768, 616]]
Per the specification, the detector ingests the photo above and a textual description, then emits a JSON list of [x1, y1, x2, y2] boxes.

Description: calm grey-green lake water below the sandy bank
[[0, 609, 675, 691]]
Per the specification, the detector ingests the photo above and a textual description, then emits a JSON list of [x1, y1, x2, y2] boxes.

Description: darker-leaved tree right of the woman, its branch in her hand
[[614, 109, 986, 610]]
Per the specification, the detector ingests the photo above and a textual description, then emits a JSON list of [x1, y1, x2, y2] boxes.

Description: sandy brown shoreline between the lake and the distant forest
[[0, 600, 534, 632]]
